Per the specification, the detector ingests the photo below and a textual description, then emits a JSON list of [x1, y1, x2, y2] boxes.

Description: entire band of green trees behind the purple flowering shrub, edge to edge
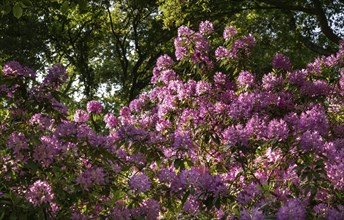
[[0, 0, 344, 105]]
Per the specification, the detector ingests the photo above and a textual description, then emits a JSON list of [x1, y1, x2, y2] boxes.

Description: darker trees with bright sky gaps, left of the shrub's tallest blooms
[[0, 1, 172, 104]]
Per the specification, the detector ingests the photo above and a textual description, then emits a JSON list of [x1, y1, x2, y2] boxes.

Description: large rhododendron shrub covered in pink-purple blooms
[[0, 21, 344, 219]]
